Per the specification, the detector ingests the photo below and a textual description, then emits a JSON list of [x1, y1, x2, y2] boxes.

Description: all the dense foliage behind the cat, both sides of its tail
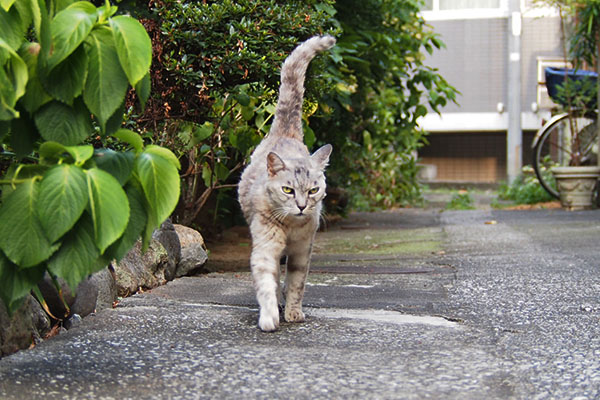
[[126, 0, 455, 224]]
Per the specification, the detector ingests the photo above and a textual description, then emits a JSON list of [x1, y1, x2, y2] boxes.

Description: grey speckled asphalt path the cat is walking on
[[0, 210, 600, 400]]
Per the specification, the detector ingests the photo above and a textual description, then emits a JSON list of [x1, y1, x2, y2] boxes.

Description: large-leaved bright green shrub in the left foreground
[[0, 0, 179, 317]]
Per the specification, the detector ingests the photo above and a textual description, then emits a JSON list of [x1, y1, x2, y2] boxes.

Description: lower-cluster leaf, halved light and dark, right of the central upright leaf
[[86, 168, 129, 254]]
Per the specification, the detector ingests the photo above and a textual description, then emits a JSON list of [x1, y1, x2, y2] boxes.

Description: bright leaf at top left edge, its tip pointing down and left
[[47, 2, 97, 71]]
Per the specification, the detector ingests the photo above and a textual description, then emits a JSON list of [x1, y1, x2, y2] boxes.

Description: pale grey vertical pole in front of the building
[[506, 0, 523, 183]]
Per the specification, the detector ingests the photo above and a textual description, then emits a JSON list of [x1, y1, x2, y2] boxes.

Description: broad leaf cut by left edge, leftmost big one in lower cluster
[[0, 179, 58, 268]]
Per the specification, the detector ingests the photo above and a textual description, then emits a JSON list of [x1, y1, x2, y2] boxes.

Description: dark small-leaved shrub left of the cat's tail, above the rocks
[[126, 0, 336, 225]]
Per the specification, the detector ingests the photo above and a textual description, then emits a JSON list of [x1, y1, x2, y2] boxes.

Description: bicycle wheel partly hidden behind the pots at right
[[533, 114, 598, 198]]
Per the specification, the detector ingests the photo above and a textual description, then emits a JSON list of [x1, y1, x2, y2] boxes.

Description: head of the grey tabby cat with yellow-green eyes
[[267, 144, 332, 218]]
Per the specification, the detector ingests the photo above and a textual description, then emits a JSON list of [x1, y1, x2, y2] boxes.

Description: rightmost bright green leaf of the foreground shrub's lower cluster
[[135, 150, 179, 233]]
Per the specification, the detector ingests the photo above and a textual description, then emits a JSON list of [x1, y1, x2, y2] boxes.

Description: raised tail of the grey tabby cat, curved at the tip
[[269, 35, 335, 141]]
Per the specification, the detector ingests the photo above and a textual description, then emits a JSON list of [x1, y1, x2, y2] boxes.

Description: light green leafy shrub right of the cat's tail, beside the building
[[310, 0, 456, 209]]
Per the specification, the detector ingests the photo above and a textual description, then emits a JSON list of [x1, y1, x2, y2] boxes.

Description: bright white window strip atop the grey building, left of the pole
[[423, 0, 508, 20]]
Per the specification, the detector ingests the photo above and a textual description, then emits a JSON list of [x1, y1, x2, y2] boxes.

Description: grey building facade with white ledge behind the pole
[[419, 0, 564, 183]]
